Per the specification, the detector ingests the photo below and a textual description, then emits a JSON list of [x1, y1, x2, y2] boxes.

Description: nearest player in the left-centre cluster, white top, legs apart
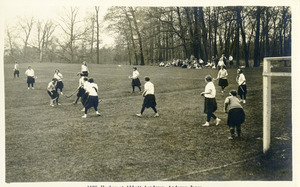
[[82, 78, 101, 118]]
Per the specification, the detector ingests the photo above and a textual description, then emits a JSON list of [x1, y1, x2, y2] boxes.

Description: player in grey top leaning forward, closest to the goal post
[[224, 90, 245, 140]]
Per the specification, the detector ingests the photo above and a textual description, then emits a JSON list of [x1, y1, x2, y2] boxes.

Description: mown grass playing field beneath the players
[[4, 63, 292, 183]]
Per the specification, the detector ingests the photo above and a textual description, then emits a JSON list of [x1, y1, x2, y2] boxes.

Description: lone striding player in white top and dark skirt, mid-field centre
[[136, 77, 159, 117]]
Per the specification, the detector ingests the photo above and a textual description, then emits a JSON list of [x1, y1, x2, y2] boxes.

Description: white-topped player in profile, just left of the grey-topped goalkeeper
[[201, 75, 221, 127]]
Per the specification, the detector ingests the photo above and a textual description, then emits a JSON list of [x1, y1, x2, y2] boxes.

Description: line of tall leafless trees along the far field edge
[[5, 6, 292, 67]]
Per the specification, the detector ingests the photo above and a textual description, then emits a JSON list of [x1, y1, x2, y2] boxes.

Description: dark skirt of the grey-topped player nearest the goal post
[[227, 108, 245, 127]]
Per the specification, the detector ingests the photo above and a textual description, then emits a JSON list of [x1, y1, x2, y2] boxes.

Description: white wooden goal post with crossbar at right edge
[[263, 57, 292, 153]]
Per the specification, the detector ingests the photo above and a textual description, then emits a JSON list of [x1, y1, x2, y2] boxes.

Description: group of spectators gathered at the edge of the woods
[[159, 54, 232, 69]]
